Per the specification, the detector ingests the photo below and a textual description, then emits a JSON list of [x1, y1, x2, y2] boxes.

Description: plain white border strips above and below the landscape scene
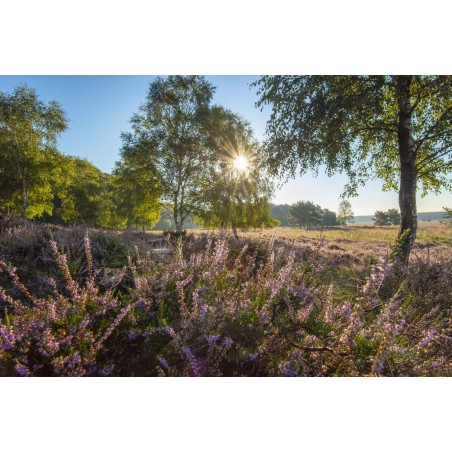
[[0, 0, 451, 452]]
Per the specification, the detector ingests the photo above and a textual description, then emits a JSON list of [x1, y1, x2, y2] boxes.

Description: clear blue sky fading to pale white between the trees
[[0, 75, 452, 215]]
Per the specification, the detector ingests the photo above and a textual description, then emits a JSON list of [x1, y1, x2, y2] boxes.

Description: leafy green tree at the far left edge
[[0, 85, 67, 218]]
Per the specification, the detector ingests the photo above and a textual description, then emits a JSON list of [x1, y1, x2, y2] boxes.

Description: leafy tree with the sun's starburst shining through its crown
[[198, 107, 279, 237]]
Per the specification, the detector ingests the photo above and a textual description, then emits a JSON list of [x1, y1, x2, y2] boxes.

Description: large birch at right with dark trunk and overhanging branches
[[255, 75, 452, 262]]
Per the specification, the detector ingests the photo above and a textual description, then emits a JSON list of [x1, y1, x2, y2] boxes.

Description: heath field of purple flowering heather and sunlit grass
[[0, 218, 452, 376]]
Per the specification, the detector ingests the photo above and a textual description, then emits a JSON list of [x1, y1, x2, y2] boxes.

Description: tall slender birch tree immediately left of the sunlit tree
[[123, 76, 219, 231]]
